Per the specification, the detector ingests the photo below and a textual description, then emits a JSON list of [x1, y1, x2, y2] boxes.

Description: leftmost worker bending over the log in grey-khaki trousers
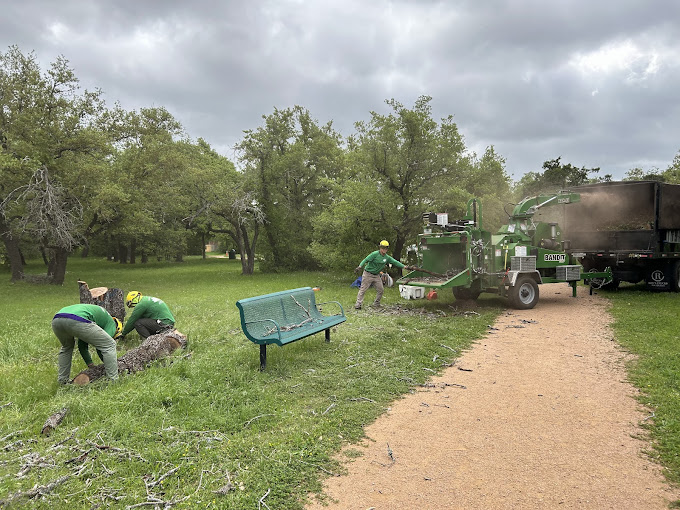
[[52, 304, 123, 384]]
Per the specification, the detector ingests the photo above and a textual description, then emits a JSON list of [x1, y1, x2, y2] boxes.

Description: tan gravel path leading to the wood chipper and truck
[[308, 284, 680, 510]]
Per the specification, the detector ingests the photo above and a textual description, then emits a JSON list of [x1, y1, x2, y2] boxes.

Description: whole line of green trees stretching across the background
[[0, 46, 680, 284]]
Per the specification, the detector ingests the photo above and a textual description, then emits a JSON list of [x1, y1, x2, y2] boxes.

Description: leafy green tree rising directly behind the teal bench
[[237, 106, 343, 271]]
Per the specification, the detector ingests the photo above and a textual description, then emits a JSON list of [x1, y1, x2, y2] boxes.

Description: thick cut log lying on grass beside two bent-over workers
[[71, 329, 187, 386]]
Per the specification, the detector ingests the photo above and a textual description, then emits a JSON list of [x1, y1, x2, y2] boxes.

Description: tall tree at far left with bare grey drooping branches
[[0, 46, 109, 284]]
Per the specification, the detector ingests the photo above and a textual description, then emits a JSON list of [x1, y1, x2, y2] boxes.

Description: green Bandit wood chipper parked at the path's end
[[397, 191, 612, 309]]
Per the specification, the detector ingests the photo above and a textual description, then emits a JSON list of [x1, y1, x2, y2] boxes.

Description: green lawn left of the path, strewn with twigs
[[0, 258, 503, 509]]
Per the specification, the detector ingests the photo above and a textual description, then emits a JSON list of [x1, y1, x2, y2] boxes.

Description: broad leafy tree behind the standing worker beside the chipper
[[311, 96, 469, 265]]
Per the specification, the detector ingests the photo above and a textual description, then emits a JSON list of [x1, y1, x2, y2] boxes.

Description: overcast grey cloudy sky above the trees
[[0, 0, 680, 180]]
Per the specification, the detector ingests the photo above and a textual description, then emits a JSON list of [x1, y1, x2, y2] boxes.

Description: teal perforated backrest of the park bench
[[236, 287, 323, 338]]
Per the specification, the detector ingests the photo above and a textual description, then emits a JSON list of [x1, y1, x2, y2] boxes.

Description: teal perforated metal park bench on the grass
[[236, 287, 347, 370]]
